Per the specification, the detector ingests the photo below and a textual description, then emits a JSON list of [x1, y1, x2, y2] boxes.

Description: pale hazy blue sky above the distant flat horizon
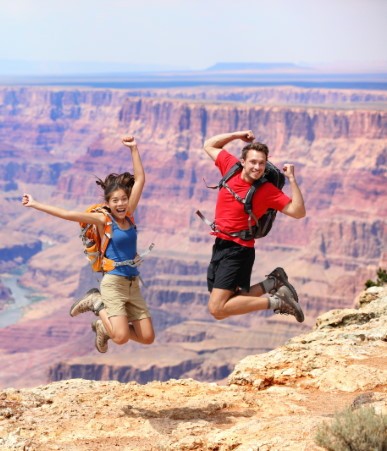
[[0, 0, 387, 69]]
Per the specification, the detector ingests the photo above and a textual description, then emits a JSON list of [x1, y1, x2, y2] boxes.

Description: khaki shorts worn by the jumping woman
[[100, 274, 151, 321]]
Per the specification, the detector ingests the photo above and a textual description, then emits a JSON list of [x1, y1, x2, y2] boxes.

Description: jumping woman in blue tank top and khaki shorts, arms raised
[[22, 136, 155, 353]]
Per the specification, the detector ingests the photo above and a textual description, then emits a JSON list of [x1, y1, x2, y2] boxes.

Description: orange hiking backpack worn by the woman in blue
[[79, 204, 134, 272]]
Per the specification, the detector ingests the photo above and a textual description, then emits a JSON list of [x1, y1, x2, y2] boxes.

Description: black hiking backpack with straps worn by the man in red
[[196, 161, 285, 241]]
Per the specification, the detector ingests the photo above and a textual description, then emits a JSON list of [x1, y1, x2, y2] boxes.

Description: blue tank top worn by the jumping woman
[[105, 219, 139, 277]]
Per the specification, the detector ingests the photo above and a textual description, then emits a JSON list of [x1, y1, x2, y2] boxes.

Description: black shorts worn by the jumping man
[[207, 238, 255, 291]]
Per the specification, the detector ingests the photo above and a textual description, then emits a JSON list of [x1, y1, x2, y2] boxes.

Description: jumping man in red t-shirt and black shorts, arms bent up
[[204, 130, 305, 322]]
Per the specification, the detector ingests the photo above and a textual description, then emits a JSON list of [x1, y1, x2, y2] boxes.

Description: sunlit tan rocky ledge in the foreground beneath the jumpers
[[0, 287, 387, 451]]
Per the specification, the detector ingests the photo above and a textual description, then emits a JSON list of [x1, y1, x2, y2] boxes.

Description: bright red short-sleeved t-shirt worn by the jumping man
[[213, 149, 291, 247]]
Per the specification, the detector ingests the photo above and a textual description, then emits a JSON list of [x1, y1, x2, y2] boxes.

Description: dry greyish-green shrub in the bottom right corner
[[315, 407, 387, 451]]
